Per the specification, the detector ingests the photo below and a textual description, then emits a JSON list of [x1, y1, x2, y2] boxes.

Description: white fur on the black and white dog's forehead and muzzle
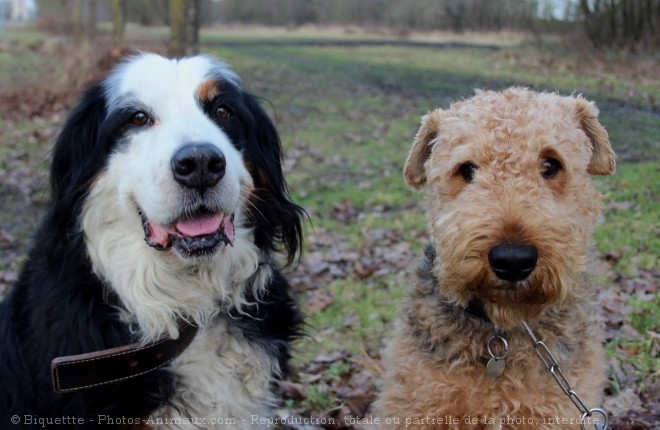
[[105, 55, 249, 228]]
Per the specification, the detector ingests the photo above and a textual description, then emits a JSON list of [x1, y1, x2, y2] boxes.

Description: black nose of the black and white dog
[[170, 143, 227, 192]]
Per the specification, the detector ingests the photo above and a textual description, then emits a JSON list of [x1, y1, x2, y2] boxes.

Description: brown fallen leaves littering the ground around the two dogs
[[0, 36, 660, 430]]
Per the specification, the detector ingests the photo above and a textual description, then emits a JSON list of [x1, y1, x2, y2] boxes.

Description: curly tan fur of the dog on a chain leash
[[375, 88, 615, 429]]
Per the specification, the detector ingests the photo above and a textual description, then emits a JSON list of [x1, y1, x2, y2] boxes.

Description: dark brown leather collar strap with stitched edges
[[50, 323, 198, 393]]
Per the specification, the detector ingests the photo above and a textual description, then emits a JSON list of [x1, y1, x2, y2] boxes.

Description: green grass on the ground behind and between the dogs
[[0, 25, 660, 411]]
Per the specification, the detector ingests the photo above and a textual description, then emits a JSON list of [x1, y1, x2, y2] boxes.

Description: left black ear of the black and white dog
[[50, 86, 107, 232]]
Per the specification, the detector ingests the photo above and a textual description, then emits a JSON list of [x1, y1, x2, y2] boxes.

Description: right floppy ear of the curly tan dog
[[575, 97, 616, 175]]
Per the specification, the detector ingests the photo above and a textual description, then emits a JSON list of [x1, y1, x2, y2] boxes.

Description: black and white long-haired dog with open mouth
[[0, 54, 304, 428]]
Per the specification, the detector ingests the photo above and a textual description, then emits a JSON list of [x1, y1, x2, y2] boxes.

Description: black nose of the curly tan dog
[[488, 243, 537, 282]]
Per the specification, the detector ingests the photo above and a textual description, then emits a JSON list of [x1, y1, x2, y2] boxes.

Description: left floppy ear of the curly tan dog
[[403, 109, 444, 189]]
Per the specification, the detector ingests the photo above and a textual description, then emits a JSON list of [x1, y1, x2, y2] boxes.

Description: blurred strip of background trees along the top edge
[[6, 0, 660, 55]]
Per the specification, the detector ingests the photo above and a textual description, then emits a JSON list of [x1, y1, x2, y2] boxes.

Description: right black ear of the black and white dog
[[243, 93, 306, 264]]
